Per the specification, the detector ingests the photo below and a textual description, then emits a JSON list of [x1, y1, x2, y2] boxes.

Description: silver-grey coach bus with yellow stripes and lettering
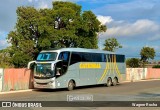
[[28, 48, 126, 90]]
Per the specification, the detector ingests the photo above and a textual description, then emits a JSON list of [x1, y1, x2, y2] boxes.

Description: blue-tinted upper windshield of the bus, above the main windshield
[[37, 52, 57, 61]]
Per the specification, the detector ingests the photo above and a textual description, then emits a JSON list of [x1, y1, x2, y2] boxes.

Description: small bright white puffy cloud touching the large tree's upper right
[[97, 15, 113, 25]]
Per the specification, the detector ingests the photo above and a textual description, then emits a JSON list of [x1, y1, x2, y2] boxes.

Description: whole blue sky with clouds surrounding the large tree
[[0, 0, 160, 60]]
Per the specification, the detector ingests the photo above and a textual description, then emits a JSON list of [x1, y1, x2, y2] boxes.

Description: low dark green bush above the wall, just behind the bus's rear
[[126, 58, 140, 68]]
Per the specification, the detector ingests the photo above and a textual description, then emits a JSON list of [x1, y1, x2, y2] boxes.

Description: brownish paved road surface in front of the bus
[[0, 80, 160, 110]]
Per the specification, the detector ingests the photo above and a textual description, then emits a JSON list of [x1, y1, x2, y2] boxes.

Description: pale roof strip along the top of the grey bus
[[41, 48, 121, 54]]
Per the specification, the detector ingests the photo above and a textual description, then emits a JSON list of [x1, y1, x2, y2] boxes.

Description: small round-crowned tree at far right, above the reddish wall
[[140, 47, 155, 63]]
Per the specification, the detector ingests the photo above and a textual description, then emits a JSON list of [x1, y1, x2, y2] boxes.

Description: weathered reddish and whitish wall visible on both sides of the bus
[[0, 68, 160, 92]]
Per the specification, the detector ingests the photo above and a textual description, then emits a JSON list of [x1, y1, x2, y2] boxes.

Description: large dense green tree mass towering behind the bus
[[7, 1, 106, 67]]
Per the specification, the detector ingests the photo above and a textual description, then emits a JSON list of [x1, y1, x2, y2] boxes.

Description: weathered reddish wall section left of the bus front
[[2, 68, 33, 91]]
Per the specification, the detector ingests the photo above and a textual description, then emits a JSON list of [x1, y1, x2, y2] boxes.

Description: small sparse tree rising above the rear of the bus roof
[[103, 38, 122, 52]]
